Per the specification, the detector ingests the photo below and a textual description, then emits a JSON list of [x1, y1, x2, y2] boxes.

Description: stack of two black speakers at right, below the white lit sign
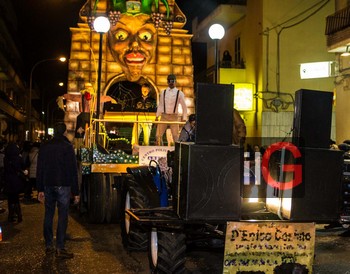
[[272, 89, 343, 222]]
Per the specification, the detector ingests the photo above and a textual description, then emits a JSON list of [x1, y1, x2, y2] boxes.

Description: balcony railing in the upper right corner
[[325, 6, 350, 35]]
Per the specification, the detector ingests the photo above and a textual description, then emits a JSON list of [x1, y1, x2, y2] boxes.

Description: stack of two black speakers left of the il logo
[[173, 83, 243, 221]]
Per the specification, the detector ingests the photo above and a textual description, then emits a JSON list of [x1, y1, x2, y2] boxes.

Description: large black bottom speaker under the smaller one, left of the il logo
[[173, 143, 243, 221]]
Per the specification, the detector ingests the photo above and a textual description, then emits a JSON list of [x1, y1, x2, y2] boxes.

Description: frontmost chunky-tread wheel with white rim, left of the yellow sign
[[148, 229, 186, 274]]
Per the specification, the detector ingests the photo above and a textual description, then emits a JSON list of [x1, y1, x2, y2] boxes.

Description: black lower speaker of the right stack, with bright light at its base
[[266, 148, 343, 222]]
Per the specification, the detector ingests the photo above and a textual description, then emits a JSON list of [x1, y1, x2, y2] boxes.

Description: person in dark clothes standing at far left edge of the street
[[4, 143, 28, 223]]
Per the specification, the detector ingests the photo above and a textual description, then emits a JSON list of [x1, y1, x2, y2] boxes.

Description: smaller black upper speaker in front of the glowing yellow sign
[[195, 83, 233, 145]]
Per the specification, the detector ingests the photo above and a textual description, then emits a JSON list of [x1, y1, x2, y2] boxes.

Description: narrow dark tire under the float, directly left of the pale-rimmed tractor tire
[[106, 174, 122, 224]]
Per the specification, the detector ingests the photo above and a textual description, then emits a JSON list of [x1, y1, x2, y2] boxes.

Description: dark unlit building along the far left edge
[[0, 0, 29, 141]]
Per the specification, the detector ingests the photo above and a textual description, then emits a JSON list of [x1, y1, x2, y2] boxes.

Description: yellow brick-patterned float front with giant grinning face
[[64, 0, 194, 152]]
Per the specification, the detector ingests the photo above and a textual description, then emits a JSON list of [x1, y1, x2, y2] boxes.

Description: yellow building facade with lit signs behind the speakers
[[193, 0, 338, 144]]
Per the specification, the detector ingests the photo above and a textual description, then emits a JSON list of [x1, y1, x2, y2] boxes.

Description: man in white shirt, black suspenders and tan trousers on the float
[[156, 74, 187, 146]]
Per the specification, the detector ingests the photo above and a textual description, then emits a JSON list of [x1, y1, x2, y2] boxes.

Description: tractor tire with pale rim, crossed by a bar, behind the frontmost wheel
[[120, 175, 149, 251]]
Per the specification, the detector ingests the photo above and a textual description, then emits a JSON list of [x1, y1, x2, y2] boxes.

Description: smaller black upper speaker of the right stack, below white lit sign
[[293, 89, 333, 148]]
